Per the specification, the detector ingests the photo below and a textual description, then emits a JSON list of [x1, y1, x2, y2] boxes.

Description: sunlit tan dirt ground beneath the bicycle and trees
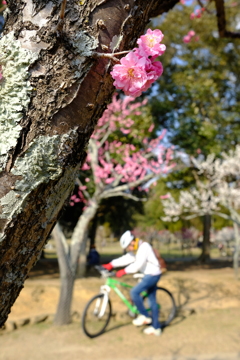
[[0, 262, 240, 360]]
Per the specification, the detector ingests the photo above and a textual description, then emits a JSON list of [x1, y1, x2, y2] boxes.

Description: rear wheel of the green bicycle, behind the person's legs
[[156, 287, 177, 328]]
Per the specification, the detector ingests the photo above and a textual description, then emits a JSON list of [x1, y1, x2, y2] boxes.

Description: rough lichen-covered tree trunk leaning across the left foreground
[[0, 0, 177, 326]]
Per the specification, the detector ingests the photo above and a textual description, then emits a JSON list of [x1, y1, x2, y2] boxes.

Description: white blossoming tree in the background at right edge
[[162, 146, 240, 276]]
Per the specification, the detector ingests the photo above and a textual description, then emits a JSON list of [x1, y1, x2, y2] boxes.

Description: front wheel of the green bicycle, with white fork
[[82, 294, 112, 338]]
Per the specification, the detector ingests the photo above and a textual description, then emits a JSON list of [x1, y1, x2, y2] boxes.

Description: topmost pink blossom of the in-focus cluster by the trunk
[[136, 29, 166, 57]]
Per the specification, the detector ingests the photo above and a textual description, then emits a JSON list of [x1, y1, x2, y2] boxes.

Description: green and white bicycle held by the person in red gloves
[[82, 266, 176, 338]]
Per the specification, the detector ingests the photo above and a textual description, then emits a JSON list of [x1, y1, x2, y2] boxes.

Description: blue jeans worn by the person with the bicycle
[[130, 275, 161, 329]]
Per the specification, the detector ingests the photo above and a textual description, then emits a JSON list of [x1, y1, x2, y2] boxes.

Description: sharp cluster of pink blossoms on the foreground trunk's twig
[[111, 29, 166, 97]]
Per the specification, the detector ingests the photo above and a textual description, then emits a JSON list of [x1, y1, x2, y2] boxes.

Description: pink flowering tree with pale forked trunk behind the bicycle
[[53, 95, 174, 324]]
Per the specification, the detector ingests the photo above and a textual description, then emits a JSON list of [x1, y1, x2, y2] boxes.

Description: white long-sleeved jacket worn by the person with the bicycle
[[111, 241, 162, 275]]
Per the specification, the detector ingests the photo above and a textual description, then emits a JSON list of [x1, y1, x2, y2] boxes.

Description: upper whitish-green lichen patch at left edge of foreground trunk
[[0, 32, 37, 169]]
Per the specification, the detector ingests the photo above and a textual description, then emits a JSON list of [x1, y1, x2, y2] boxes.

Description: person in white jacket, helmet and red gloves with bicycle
[[103, 230, 162, 335]]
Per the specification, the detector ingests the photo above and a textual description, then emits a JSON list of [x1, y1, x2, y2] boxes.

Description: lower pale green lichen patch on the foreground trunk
[[0, 130, 77, 219]]
